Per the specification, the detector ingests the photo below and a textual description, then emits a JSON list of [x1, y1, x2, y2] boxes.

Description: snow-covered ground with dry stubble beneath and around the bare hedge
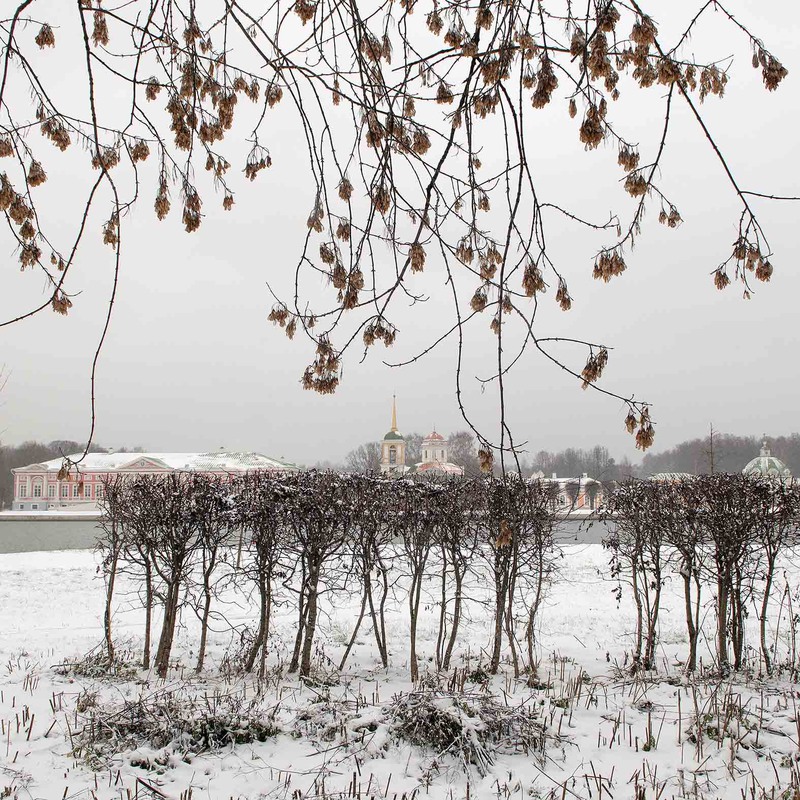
[[0, 545, 800, 800]]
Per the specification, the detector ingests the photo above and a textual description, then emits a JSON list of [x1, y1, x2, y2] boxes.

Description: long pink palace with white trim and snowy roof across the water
[[11, 452, 297, 511]]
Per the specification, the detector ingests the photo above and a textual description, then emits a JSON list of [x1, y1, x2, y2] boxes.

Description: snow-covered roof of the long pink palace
[[12, 452, 297, 472]]
